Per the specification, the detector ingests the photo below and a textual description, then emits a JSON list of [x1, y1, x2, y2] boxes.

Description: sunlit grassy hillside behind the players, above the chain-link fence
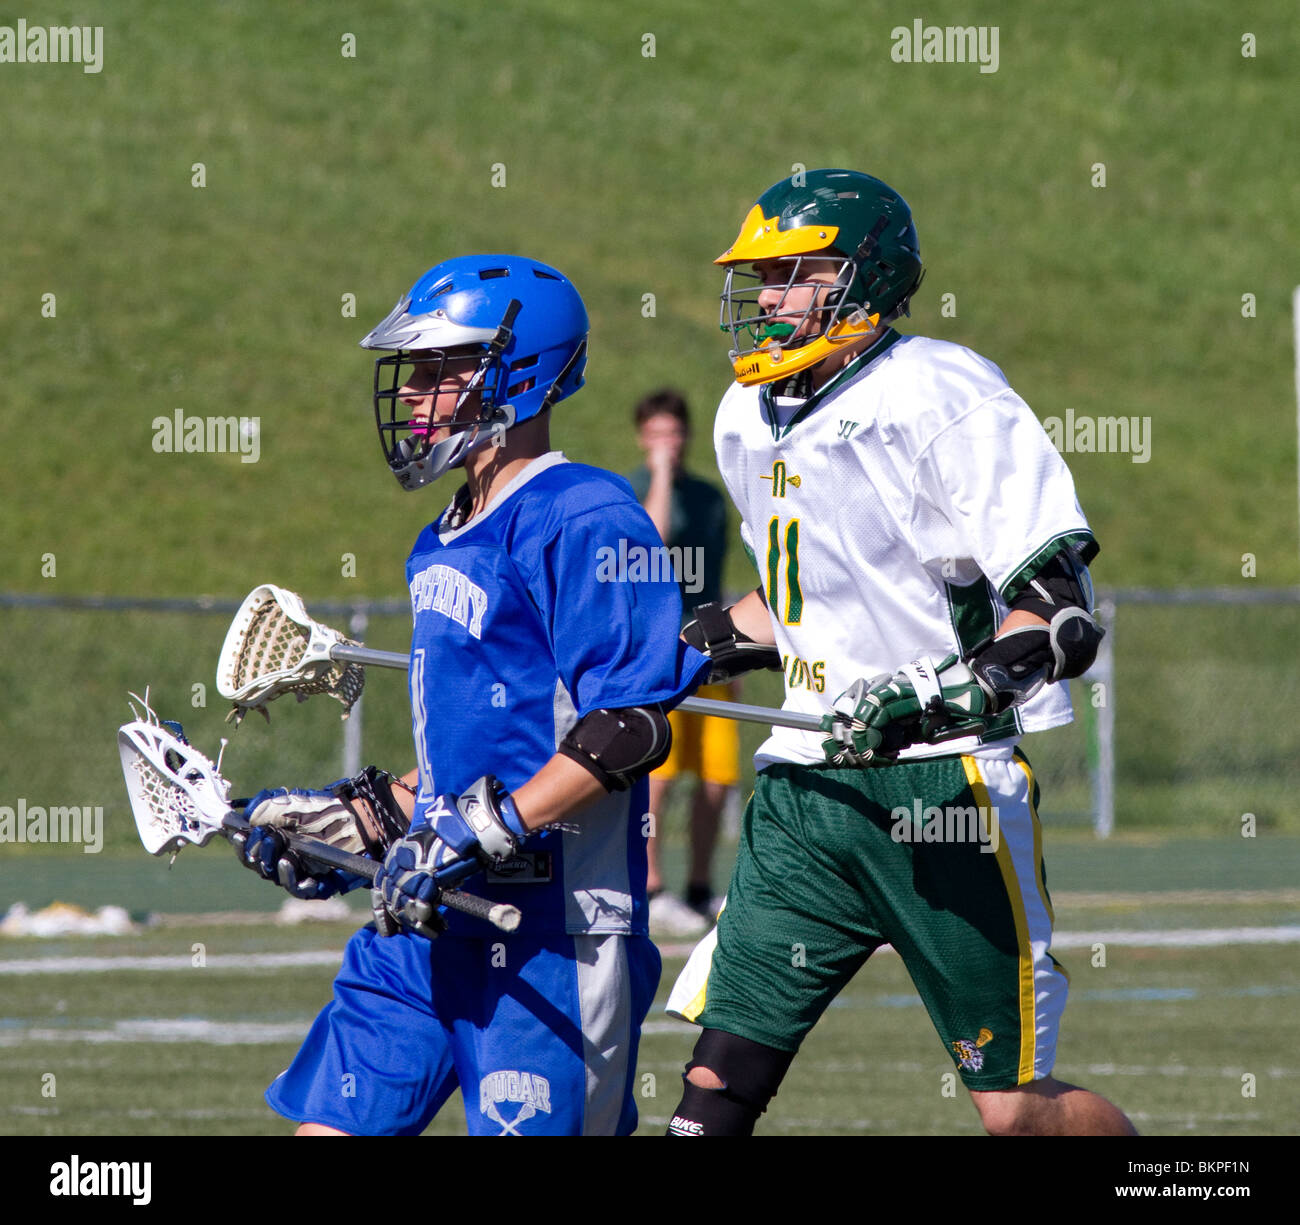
[[0, 0, 1300, 598]]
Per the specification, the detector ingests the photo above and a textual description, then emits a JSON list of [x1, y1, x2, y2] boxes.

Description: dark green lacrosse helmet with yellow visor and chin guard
[[714, 170, 924, 385]]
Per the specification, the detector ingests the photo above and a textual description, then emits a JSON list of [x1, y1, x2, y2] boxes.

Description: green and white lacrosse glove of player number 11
[[822, 655, 997, 766]]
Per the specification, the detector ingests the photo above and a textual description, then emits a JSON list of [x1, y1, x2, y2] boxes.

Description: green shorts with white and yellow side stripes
[[668, 749, 1067, 1090]]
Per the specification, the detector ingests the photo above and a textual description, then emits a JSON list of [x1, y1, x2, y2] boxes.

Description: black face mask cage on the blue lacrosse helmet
[[374, 349, 504, 468]]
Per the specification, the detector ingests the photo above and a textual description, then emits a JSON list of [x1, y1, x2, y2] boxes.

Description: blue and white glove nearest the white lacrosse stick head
[[231, 766, 410, 900]]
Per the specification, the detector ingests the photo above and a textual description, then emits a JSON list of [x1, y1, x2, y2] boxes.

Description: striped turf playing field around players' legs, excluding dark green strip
[[0, 869, 1300, 1135]]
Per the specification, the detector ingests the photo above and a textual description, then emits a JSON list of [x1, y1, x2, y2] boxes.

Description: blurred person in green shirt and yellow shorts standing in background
[[628, 389, 740, 936]]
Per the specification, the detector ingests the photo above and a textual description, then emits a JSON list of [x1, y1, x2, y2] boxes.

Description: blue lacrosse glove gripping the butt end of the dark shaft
[[371, 774, 529, 936]]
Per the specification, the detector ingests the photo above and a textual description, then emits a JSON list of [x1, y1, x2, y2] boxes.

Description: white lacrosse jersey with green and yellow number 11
[[714, 330, 1096, 769]]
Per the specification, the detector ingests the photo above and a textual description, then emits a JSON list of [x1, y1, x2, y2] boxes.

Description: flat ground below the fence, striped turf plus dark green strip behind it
[[0, 830, 1300, 1135]]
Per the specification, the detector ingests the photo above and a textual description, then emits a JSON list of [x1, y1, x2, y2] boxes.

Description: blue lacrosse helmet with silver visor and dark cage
[[361, 255, 589, 489]]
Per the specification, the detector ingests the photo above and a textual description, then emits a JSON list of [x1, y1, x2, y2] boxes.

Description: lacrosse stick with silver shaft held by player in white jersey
[[217, 583, 822, 732]]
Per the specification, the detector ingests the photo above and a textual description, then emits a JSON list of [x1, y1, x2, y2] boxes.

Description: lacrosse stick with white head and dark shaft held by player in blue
[[117, 693, 520, 935]]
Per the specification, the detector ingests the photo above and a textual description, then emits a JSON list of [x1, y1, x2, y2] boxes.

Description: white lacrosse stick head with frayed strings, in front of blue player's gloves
[[117, 693, 230, 854]]
